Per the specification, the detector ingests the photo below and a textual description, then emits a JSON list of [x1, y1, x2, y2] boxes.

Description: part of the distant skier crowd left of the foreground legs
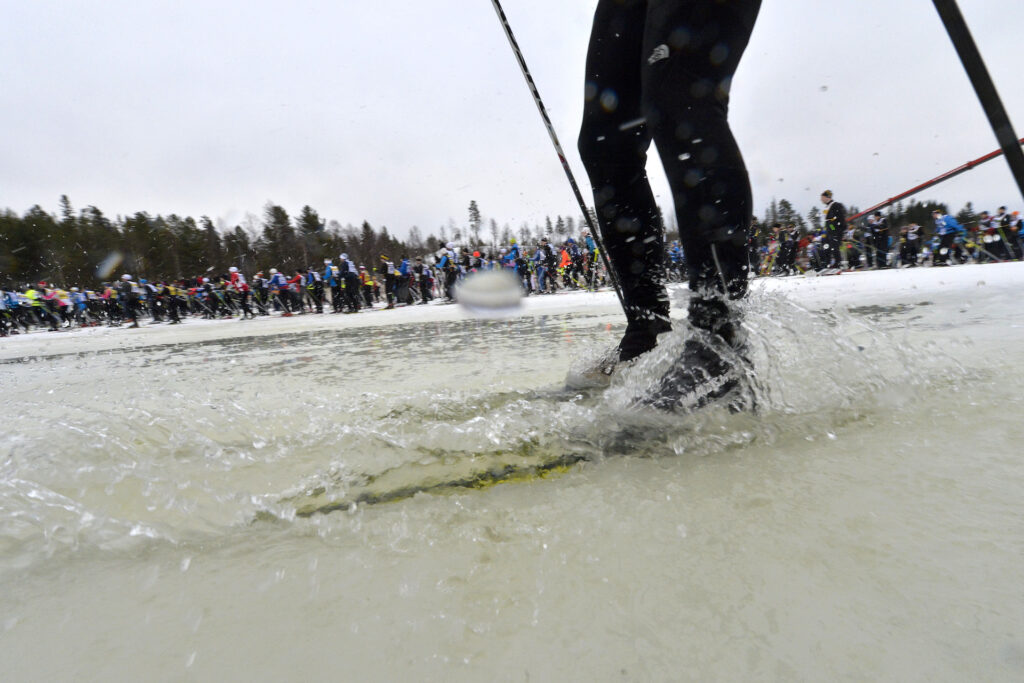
[[0, 230, 607, 336]]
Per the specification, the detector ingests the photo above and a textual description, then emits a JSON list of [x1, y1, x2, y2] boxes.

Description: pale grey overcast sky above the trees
[[0, 0, 1024, 234]]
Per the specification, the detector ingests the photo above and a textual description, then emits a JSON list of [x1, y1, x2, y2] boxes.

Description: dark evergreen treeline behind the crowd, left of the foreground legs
[[0, 196, 602, 287]]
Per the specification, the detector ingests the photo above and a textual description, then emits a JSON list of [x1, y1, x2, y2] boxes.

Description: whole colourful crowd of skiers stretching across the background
[[0, 201, 1024, 336]]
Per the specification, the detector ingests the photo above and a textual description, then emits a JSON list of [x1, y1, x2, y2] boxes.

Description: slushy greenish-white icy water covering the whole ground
[[0, 266, 1024, 681]]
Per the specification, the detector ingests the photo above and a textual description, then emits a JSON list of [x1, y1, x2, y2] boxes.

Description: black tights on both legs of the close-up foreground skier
[[579, 0, 761, 359]]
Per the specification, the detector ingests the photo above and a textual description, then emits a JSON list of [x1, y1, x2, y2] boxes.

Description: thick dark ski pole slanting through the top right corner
[[933, 0, 1024, 204]]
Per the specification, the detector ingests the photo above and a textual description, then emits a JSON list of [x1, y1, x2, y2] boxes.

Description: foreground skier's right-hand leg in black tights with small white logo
[[643, 0, 761, 317]]
